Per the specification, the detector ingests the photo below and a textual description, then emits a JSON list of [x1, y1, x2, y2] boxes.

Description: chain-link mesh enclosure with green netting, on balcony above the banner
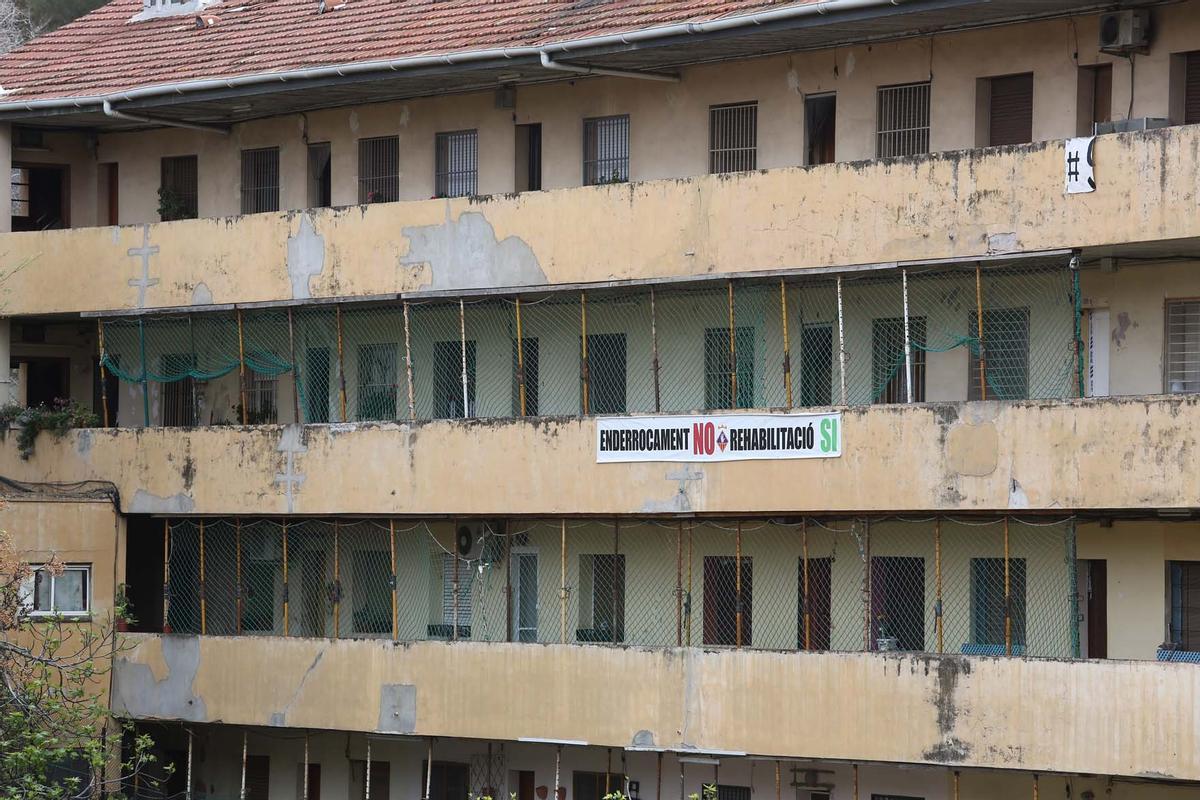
[[97, 259, 1080, 426]]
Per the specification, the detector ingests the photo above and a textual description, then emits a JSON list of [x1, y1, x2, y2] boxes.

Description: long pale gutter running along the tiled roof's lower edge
[[0, 0, 902, 115]]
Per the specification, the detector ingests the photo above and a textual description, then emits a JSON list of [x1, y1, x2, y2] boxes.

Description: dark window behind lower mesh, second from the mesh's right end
[[871, 555, 925, 651]]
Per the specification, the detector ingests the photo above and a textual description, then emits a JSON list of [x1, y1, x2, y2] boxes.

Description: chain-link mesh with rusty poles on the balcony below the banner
[[159, 518, 1079, 657]]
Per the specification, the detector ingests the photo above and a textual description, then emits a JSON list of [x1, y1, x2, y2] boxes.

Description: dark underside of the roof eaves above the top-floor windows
[[7, 0, 1171, 130]]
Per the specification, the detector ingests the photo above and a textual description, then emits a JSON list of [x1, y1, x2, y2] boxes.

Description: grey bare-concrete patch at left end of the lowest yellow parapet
[[113, 636, 208, 722]]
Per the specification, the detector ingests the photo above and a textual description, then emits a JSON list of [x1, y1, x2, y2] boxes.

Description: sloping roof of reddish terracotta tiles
[[0, 0, 816, 102]]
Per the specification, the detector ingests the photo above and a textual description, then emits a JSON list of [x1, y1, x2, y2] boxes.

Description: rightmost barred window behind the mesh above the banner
[[967, 308, 1030, 399]]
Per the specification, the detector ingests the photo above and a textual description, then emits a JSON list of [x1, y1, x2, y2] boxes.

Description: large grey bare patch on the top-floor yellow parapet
[[400, 209, 548, 289]]
